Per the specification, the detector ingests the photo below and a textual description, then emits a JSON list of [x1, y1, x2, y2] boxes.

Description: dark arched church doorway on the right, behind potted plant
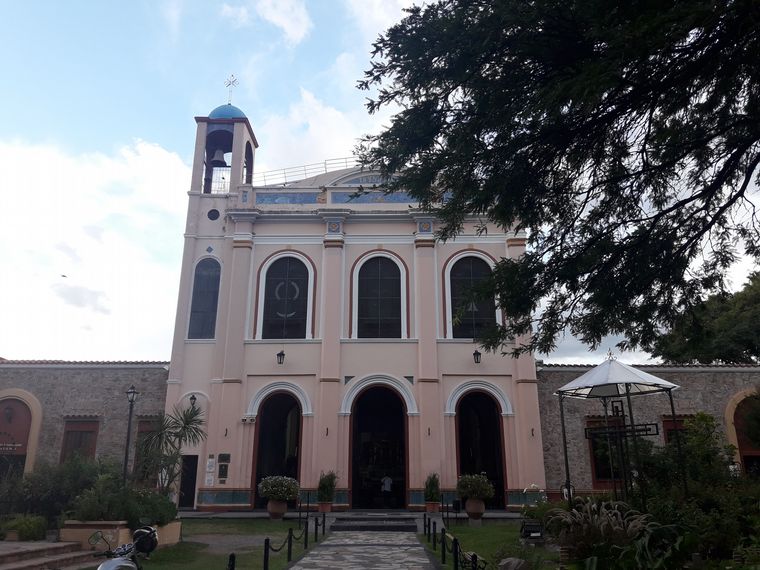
[[456, 391, 504, 508]]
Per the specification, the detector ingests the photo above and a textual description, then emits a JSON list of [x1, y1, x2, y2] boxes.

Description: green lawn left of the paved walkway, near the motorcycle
[[84, 519, 322, 570]]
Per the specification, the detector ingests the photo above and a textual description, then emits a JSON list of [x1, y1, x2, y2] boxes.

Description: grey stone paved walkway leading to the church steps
[[291, 532, 435, 570]]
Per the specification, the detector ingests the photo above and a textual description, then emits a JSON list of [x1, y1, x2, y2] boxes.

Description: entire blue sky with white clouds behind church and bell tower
[[0, 0, 664, 362]]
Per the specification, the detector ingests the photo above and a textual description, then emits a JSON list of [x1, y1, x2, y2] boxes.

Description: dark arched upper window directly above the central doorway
[[356, 256, 402, 338]]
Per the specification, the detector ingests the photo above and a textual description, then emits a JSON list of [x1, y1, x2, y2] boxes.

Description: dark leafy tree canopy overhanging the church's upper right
[[359, 0, 760, 353]]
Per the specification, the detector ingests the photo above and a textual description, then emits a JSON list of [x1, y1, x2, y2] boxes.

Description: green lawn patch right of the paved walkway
[[420, 520, 559, 568]]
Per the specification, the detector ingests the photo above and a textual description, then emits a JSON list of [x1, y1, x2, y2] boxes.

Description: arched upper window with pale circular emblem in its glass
[[261, 256, 309, 338]]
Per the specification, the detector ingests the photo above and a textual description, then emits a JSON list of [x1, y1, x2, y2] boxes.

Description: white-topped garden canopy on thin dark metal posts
[[555, 355, 688, 501]]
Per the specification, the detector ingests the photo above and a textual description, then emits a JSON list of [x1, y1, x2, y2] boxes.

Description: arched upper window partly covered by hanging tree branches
[[449, 256, 496, 338]]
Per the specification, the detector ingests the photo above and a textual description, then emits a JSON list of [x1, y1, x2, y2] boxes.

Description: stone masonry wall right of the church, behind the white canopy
[[538, 364, 760, 491]]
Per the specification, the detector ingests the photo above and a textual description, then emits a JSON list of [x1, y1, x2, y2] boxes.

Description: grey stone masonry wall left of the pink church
[[0, 361, 168, 463]]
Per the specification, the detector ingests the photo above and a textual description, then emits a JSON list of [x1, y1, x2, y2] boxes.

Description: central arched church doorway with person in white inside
[[351, 386, 406, 509]]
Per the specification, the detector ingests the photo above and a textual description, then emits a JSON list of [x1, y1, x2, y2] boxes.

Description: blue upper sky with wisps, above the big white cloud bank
[[0, 0, 392, 162]]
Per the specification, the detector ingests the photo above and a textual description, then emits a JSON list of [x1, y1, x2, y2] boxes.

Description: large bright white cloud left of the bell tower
[[0, 141, 190, 360]]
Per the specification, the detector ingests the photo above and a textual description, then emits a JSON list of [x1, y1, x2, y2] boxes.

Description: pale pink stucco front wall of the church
[[166, 111, 544, 507]]
